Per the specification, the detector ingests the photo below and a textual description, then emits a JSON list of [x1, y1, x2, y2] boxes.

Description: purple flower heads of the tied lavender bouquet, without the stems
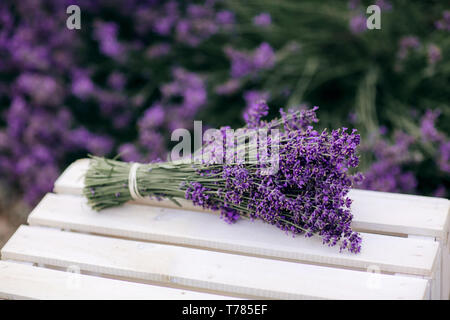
[[185, 107, 361, 253]]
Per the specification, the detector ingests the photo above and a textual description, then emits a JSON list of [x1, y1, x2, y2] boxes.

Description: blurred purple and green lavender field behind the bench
[[0, 0, 450, 231]]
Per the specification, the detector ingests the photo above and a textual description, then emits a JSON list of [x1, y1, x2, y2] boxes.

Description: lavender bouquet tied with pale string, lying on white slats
[[83, 101, 361, 253]]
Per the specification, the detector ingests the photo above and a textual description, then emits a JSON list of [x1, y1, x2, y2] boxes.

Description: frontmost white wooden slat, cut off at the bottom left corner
[[0, 261, 234, 300]]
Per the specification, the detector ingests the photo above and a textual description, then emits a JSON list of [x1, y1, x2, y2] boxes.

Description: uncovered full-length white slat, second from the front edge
[[1, 226, 428, 299]]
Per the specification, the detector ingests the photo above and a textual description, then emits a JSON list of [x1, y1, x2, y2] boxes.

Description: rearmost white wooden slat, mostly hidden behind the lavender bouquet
[[54, 159, 450, 239]]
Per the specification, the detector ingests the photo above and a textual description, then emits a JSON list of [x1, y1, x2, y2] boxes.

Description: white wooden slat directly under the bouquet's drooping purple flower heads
[[28, 194, 439, 276]]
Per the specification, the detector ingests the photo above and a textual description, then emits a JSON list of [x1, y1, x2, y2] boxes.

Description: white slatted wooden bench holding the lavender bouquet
[[0, 159, 450, 299]]
